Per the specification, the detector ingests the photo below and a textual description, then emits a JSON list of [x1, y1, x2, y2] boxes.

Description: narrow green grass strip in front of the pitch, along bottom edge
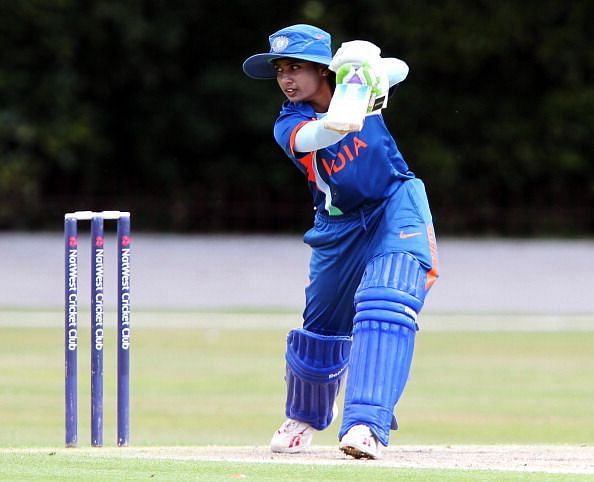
[[0, 453, 594, 482]]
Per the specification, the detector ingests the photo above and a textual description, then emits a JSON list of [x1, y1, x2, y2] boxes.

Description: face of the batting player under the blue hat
[[274, 59, 332, 112]]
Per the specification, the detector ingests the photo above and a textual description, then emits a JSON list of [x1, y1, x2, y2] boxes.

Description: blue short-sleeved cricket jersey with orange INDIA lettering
[[274, 101, 415, 215]]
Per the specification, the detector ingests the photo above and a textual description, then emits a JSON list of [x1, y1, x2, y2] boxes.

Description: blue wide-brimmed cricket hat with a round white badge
[[243, 24, 332, 79]]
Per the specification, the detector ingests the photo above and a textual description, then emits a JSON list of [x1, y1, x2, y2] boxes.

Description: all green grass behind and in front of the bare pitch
[[0, 313, 594, 481]]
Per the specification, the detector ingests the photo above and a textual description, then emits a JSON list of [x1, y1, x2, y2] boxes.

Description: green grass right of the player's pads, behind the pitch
[[397, 332, 594, 444]]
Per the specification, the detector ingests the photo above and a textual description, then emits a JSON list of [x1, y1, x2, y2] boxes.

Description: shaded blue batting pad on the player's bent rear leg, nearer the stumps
[[285, 328, 351, 430]]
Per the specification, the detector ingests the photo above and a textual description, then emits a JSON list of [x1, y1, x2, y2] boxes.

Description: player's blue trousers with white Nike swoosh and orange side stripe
[[303, 179, 437, 336]]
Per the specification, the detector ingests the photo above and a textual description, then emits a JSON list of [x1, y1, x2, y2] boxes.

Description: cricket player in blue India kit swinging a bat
[[243, 24, 438, 459]]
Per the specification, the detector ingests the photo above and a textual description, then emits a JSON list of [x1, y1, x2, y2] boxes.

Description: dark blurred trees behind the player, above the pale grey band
[[0, 0, 594, 236]]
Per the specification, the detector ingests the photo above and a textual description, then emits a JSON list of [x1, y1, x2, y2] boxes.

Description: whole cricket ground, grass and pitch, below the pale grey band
[[0, 309, 594, 481]]
